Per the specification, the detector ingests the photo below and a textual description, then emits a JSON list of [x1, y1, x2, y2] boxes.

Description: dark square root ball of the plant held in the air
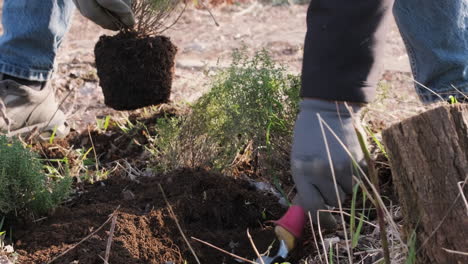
[[94, 32, 177, 110]]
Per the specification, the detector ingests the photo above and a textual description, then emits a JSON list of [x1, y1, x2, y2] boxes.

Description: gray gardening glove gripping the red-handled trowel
[[291, 99, 363, 229]]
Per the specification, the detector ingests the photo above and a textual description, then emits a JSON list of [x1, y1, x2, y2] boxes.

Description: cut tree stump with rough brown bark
[[382, 104, 468, 264]]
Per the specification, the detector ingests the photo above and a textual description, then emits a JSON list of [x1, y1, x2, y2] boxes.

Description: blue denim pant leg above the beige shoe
[[0, 0, 74, 81]]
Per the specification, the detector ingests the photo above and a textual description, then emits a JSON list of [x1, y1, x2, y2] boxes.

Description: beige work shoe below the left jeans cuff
[[0, 74, 69, 140]]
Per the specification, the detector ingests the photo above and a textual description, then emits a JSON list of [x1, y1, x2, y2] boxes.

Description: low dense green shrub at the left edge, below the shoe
[[0, 135, 71, 215]]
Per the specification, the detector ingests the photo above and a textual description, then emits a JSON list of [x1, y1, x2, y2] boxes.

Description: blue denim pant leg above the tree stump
[[393, 0, 468, 103]]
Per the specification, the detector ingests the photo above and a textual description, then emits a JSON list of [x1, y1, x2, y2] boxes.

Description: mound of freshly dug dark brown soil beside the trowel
[[16, 170, 284, 264]]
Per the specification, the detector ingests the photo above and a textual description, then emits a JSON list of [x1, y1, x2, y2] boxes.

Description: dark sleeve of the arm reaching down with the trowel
[[301, 0, 393, 102]]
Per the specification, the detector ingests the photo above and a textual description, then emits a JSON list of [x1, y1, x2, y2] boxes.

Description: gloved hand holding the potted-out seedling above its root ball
[[73, 0, 135, 30]]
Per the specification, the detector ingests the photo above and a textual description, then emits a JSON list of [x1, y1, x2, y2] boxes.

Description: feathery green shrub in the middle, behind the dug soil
[[153, 51, 300, 175]]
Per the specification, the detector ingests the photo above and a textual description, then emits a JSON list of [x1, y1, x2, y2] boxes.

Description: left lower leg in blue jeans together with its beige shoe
[[0, 0, 74, 137]]
